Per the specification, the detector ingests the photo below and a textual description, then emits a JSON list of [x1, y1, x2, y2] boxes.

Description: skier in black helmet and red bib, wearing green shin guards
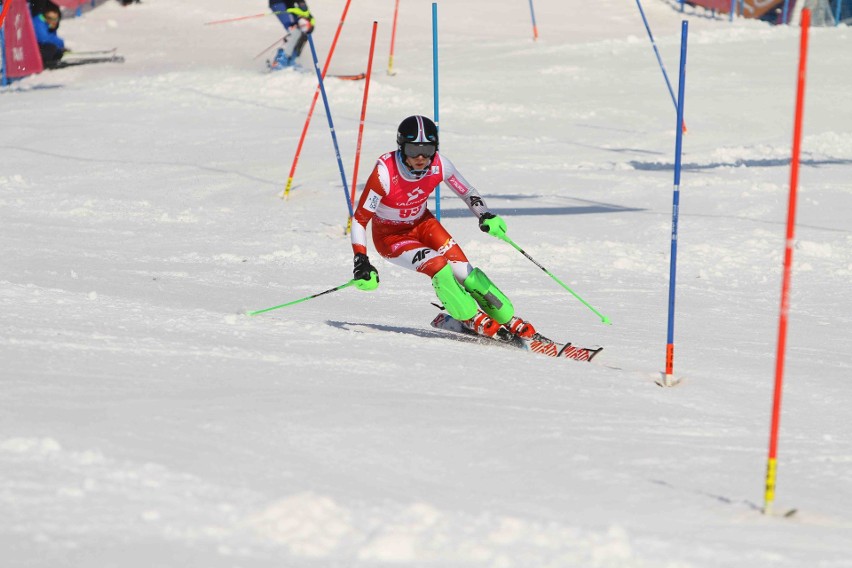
[[351, 116, 535, 337]]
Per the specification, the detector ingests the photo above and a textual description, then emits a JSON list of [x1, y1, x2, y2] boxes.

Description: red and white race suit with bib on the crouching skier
[[351, 151, 488, 281]]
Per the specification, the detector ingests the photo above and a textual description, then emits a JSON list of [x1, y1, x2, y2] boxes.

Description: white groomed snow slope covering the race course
[[0, 0, 852, 568]]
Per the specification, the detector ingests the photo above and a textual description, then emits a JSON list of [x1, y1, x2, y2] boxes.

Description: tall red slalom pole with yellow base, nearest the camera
[[763, 8, 811, 515]]
